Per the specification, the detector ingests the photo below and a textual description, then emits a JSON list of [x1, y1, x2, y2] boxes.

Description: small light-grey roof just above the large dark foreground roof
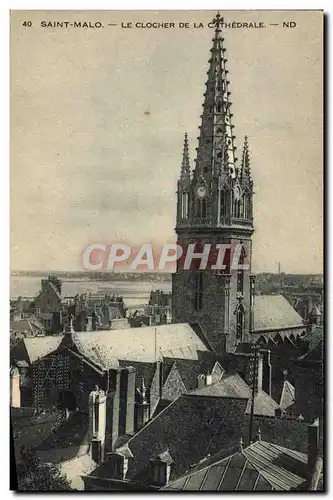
[[191, 373, 279, 417]]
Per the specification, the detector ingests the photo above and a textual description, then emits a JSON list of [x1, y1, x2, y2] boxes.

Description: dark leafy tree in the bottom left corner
[[16, 449, 72, 491]]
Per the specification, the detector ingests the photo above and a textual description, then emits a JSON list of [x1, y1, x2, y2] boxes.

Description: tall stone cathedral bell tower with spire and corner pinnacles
[[172, 14, 254, 353]]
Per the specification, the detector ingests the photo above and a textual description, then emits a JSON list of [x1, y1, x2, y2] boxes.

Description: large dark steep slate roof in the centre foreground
[[121, 395, 247, 481]]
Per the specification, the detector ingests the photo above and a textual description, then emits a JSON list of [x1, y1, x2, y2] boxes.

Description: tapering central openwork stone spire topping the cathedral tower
[[195, 13, 236, 181]]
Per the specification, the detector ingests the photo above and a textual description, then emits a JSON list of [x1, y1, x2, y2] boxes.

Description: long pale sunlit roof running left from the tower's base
[[12, 323, 209, 369]]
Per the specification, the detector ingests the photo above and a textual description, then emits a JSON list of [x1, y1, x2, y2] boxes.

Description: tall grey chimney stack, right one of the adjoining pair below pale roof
[[119, 366, 135, 436]]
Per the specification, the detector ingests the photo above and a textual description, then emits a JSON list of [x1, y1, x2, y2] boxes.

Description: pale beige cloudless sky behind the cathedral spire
[[11, 11, 323, 273]]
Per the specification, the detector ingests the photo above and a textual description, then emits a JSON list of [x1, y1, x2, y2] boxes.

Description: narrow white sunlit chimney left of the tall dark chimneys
[[89, 385, 106, 464]]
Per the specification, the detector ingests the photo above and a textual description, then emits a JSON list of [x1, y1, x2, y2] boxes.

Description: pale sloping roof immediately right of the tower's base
[[254, 295, 304, 332]]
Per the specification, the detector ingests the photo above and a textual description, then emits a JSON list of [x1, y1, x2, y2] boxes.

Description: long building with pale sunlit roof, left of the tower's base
[[11, 324, 214, 436]]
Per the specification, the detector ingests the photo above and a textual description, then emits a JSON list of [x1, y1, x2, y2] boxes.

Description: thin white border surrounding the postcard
[[0, 0, 333, 498]]
